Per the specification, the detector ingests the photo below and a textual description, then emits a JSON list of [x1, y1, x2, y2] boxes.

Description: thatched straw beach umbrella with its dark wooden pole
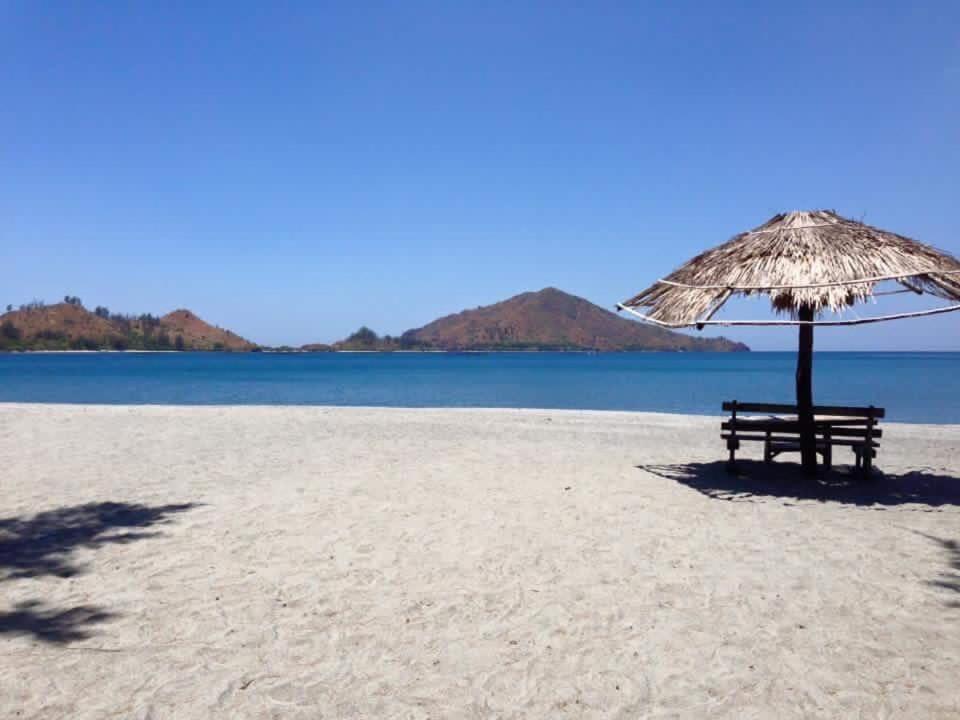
[[618, 210, 960, 473]]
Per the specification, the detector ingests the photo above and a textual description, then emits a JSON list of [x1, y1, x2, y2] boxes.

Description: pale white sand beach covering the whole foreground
[[0, 405, 960, 720]]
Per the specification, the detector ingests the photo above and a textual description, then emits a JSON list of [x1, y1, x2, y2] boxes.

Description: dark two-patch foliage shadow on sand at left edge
[[0, 502, 195, 644]]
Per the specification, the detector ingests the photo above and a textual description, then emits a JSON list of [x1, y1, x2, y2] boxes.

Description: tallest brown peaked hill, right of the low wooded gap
[[402, 288, 749, 352]]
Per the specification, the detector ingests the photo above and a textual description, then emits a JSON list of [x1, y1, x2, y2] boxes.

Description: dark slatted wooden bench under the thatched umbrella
[[720, 400, 886, 476]]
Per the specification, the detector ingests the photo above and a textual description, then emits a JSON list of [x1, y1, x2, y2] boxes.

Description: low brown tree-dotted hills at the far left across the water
[[0, 297, 256, 351]]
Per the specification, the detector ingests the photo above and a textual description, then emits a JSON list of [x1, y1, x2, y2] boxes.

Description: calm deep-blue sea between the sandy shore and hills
[[0, 352, 960, 423]]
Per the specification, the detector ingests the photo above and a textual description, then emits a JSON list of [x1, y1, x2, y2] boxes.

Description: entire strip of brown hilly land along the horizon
[[0, 288, 749, 352]]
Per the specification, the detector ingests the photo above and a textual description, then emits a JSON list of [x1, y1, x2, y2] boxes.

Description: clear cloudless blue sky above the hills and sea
[[0, 0, 960, 350]]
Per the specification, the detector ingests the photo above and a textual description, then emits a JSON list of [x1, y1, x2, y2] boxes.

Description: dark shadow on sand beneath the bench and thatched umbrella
[[637, 460, 960, 512]]
